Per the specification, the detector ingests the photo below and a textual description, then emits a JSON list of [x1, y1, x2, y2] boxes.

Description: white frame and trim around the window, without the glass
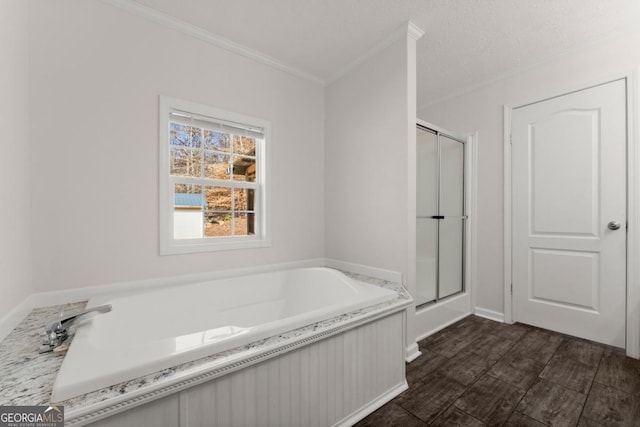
[[158, 95, 271, 255]]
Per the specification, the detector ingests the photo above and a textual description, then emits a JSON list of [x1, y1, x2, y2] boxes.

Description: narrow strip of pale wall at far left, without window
[[0, 0, 32, 318]]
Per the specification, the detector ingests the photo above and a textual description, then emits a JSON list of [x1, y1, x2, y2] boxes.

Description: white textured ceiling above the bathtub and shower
[[130, 0, 640, 106]]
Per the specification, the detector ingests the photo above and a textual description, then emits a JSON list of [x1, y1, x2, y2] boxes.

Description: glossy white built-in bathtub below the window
[[51, 268, 397, 402]]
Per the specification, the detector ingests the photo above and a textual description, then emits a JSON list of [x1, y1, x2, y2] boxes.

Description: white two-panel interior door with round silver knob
[[511, 79, 627, 347]]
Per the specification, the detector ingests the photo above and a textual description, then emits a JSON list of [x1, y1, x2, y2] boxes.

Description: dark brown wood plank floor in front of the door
[[357, 316, 640, 427]]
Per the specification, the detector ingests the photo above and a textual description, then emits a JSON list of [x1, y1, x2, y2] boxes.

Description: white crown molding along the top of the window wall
[[102, 0, 325, 86]]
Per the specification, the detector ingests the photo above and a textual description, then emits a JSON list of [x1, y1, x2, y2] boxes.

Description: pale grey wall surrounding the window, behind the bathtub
[[25, 0, 324, 298]]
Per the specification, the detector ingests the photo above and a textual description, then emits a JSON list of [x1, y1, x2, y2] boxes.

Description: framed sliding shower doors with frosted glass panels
[[416, 124, 467, 306]]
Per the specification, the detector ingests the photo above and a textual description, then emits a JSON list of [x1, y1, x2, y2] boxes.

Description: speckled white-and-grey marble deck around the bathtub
[[0, 272, 412, 420]]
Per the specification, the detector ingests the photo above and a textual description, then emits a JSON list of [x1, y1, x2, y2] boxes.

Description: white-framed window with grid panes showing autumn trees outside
[[159, 96, 270, 254]]
